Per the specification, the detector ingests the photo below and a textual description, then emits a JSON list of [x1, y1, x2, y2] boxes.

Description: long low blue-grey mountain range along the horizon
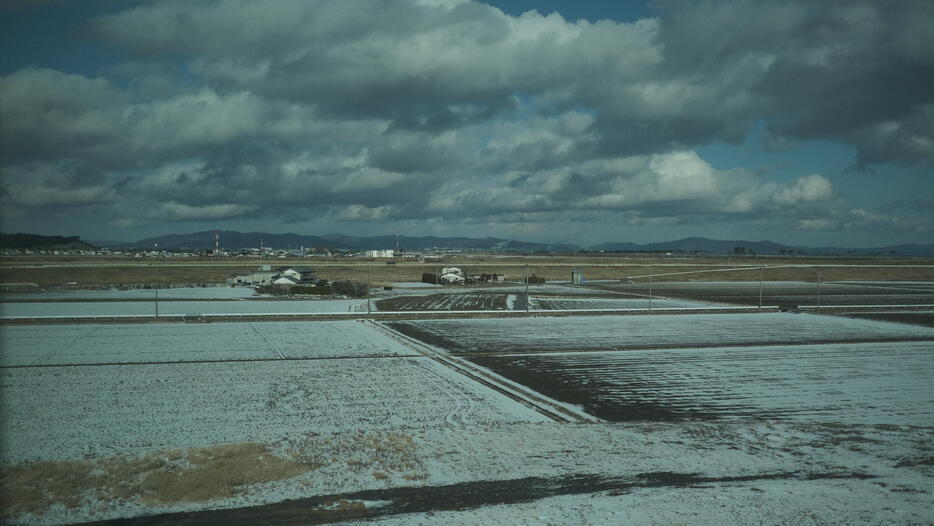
[[86, 230, 934, 257]]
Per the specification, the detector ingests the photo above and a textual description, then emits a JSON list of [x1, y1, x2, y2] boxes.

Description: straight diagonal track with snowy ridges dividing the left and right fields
[[361, 320, 601, 423]]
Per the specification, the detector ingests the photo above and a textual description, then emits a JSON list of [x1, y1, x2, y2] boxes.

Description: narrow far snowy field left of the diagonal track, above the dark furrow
[[0, 321, 415, 366]]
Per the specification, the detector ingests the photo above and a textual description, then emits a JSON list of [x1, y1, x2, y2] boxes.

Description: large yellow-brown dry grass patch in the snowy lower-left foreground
[[0, 443, 317, 517]]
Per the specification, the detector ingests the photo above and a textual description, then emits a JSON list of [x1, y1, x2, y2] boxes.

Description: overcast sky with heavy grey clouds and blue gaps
[[0, 0, 934, 246]]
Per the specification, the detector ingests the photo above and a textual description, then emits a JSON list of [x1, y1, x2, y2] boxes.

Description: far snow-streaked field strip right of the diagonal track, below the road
[[399, 312, 934, 353]]
